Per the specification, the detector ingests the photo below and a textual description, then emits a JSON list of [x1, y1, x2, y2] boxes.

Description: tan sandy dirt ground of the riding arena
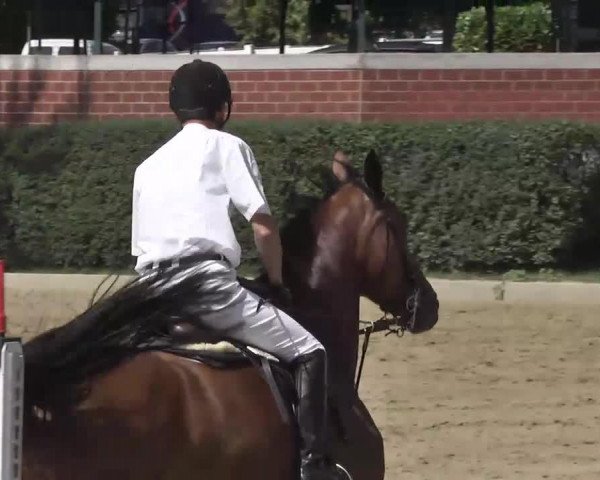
[[7, 289, 600, 480]]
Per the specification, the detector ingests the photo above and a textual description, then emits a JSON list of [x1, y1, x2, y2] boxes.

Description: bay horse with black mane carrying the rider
[[22, 152, 438, 480]]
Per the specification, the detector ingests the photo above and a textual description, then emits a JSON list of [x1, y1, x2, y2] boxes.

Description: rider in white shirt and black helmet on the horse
[[131, 60, 338, 480]]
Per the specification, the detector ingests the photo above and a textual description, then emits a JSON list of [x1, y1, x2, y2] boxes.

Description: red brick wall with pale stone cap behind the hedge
[[0, 54, 600, 125]]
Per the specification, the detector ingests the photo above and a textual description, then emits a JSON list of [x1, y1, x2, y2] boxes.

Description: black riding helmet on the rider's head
[[169, 60, 233, 128]]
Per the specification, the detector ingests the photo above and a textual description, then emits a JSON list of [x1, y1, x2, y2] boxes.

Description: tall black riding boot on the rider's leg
[[295, 350, 340, 480]]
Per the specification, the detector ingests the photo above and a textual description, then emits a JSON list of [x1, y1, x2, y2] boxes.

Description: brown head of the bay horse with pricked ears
[[312, 151, 439, 333]]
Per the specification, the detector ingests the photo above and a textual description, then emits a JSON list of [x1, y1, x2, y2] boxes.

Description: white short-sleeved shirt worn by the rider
[[131, 123, 270, 272]]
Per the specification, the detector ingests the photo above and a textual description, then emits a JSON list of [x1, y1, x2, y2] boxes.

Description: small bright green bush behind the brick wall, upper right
[[454, 2, 553, 52]]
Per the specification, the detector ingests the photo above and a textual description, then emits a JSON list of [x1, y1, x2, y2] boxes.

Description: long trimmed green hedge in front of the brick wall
[[0, 120, 600, 271]]
